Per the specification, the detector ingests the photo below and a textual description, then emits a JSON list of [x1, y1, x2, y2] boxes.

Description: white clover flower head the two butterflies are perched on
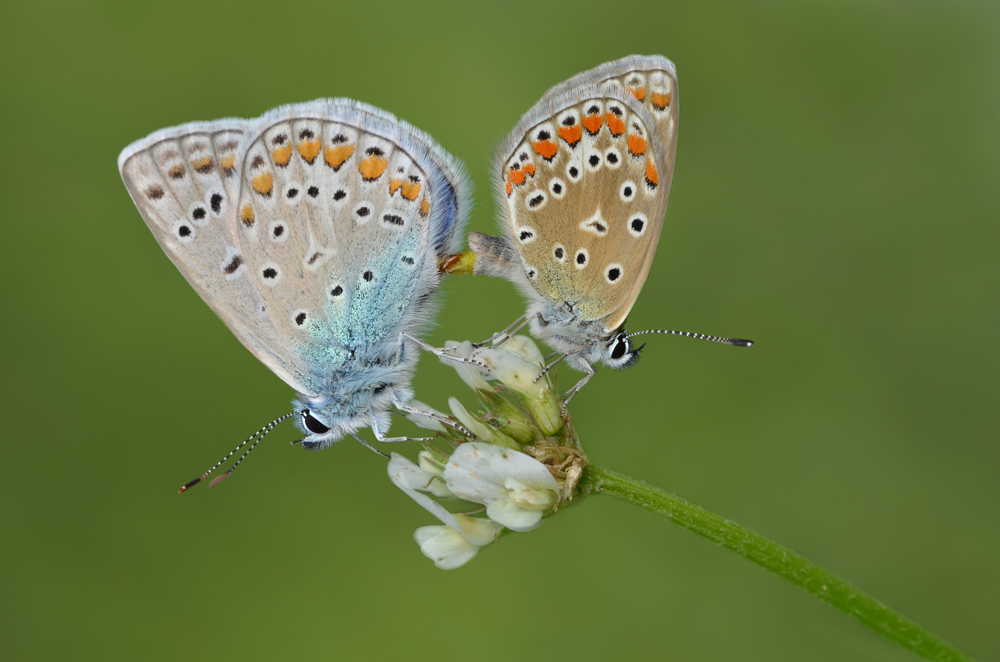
[[389, 336, 587, 569]]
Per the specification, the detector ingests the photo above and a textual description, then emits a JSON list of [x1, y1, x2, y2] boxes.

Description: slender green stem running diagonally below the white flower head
[[580, 466, 972, 662]]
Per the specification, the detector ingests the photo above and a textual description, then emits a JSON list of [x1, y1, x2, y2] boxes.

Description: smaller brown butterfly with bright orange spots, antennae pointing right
[[460, 55, 753, 411]]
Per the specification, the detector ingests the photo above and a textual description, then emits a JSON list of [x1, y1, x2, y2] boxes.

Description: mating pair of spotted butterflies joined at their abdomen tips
[[118, 56, 746, 491]]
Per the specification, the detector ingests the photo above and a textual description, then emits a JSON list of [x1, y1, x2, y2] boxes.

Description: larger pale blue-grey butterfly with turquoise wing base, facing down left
[[118, 99, 470, 491]]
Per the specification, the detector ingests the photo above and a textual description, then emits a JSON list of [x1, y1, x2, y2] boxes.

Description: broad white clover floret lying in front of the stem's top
[[444, 441, 560, 531]]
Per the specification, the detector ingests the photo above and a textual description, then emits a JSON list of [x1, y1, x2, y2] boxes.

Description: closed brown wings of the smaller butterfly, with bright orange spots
[[498, 57, 677, 331]]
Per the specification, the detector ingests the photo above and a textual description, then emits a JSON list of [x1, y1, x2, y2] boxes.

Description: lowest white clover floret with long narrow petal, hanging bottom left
[[389, 453, 503, 570]]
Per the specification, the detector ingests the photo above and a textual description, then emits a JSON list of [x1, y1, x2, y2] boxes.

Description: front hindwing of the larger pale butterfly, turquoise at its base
[[237, 117, 437, 374]]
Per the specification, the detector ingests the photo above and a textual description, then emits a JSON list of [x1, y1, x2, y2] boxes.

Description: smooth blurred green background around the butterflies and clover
[[0, 0, 1000, 661]]
